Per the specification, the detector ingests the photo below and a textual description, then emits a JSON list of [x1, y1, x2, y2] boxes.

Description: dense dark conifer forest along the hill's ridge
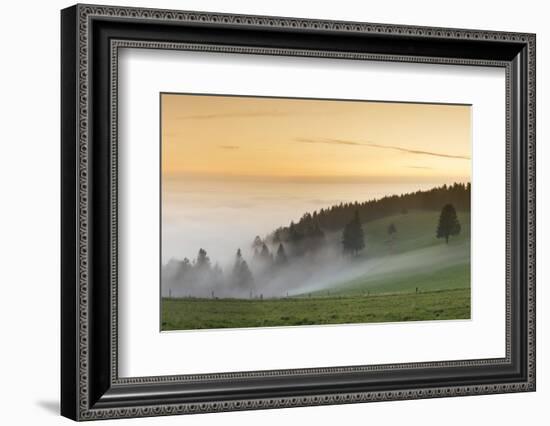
[[267, 182, 471, 241]]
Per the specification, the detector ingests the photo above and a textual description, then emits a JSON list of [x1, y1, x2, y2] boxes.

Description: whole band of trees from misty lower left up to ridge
[[162, 183, 471, 298]]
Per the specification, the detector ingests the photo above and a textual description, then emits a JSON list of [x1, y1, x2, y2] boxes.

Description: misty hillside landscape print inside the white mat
[[160, 93, 472, 331]]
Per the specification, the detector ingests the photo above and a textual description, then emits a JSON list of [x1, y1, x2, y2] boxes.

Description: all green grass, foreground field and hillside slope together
[[161, 211, 470, 330]]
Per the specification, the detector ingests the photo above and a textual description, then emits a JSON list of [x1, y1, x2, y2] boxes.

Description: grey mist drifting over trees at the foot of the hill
[[162, 242, 369, 298]]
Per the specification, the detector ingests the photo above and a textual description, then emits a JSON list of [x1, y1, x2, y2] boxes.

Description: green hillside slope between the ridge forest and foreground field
[[308, 211, 470, 296]]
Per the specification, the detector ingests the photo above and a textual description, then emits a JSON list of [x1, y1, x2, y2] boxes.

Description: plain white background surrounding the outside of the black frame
[[0, 0, 550, 426]]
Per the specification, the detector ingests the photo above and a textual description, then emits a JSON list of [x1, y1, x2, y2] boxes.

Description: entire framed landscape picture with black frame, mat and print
[[61, 5, 535, 420]]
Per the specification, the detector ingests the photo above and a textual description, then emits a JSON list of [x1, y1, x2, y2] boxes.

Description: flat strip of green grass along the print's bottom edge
[[162, 289, 470, 330]]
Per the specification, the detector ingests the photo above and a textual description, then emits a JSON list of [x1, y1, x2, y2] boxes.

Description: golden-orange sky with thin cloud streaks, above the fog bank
[[161, 94, 471, 182]]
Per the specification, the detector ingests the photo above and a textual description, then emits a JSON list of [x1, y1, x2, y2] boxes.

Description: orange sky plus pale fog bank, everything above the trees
[[161, 94, 471, 265]]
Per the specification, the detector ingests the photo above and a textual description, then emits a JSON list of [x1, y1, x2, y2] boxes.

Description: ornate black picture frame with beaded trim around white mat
[[61, 5, 535, 420]]
